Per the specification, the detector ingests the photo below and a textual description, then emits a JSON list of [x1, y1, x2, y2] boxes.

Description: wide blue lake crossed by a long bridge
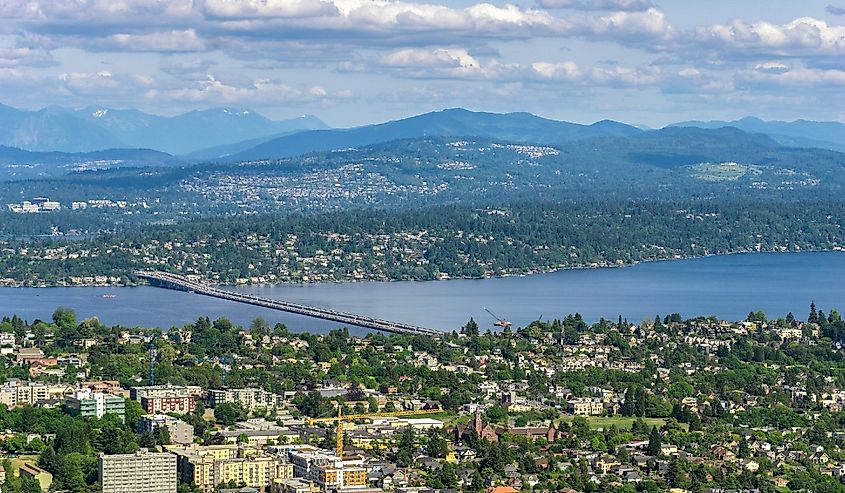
[[0, 252, 845, 334]]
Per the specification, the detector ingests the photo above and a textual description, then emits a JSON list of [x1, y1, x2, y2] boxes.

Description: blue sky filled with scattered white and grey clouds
[[0, 0, 845, 127]]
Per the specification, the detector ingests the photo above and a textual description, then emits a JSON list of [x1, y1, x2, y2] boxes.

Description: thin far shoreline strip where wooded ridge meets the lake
[[0, 246, 845, 289]]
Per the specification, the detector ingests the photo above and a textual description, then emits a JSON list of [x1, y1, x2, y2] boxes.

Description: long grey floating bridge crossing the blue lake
[[135, 271, 443, 337]]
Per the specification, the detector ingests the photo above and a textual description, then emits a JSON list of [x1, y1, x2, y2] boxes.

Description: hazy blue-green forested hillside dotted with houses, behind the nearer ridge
[[0, 128, 845, 235]]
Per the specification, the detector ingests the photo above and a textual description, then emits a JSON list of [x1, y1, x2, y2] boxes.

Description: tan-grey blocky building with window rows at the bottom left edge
[[100, 449, 177, 493]]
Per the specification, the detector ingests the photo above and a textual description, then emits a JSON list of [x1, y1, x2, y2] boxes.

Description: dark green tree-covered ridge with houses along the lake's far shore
[[0, 201, 845, 284]]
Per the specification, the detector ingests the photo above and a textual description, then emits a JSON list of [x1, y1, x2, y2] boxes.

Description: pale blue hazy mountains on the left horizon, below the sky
[[0, 105, 328, 155]]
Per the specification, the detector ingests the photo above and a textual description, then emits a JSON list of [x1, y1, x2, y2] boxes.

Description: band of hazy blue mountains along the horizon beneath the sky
[[0, 105, 845, 171]]
